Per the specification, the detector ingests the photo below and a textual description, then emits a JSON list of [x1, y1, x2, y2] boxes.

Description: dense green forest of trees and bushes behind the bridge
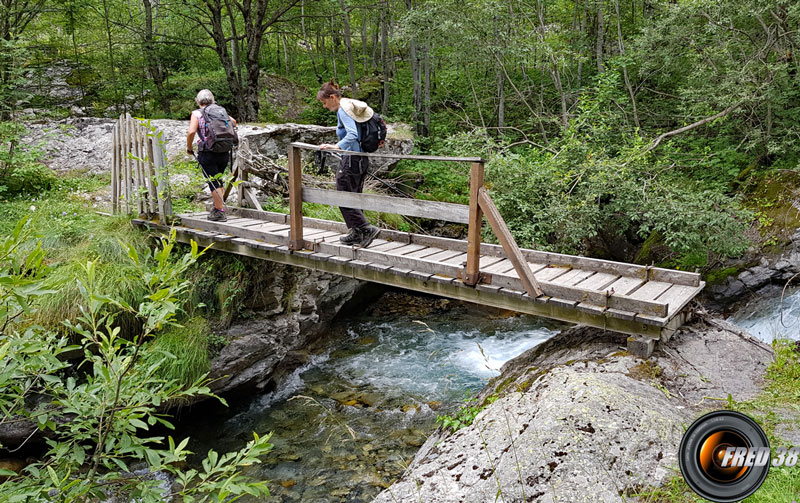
[[0, 0, 800, 269]]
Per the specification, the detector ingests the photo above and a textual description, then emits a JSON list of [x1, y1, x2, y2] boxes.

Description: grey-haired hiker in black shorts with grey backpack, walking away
[[186, 89, 239, 222]]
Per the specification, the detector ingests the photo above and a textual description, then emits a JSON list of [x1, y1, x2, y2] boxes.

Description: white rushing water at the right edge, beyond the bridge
[[728, 288, 800, 343]]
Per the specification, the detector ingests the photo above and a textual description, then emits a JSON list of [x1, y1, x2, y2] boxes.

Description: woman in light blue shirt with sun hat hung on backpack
[[317, 79, 386, 248]]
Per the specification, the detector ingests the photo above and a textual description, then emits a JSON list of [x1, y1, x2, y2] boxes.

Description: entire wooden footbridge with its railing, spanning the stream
[[116, 133, 705, 356]]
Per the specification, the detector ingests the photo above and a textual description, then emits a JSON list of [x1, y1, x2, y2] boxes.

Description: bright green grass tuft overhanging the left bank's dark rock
[[142, 317, 211, 386]]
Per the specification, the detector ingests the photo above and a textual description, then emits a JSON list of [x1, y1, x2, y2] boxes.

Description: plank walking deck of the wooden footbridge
[[167, 213, 698, 326]]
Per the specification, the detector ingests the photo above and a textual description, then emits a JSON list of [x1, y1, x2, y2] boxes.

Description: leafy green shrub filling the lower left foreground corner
[[0, 221, 271, 502]]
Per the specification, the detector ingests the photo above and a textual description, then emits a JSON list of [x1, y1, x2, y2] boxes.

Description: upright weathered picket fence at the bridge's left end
[[111, 114, 172, 223]]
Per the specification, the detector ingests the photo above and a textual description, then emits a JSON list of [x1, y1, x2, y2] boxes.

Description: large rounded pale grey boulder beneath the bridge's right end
[[374, 318, 772, 503]]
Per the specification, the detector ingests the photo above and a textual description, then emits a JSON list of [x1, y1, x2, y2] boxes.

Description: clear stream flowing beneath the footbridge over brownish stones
[[183, 294, 563, 503]]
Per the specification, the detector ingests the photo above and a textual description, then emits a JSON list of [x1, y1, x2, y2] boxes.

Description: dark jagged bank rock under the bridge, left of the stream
[[209, 262, 364, 393]]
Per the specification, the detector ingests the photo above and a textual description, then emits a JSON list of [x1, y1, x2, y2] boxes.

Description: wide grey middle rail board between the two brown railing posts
[[303, 187, 469, 224]]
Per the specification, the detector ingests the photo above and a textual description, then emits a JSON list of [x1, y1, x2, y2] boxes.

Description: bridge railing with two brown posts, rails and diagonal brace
[[289, 143, 542, 298]]
